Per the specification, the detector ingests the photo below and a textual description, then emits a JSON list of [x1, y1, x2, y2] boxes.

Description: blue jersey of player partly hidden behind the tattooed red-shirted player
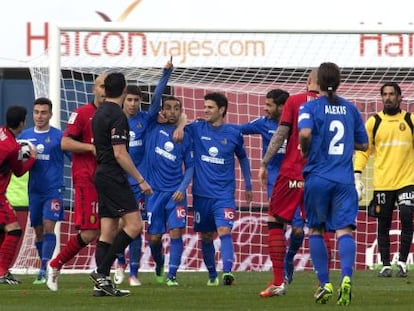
[[239, 116, 286, 197]]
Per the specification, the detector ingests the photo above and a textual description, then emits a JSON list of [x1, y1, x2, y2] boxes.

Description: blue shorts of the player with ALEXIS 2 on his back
[[305, 175, 358, 231]]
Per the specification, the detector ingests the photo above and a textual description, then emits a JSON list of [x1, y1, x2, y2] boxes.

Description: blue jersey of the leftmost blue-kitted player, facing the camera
[[19, 127, 64, 196]]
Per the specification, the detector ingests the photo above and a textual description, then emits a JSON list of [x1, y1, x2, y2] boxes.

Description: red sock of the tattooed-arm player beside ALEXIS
[[267, 229, 286, 285]]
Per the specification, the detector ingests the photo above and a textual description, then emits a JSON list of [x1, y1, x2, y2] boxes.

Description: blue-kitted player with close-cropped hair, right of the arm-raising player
[[145, 96, 194, 286]]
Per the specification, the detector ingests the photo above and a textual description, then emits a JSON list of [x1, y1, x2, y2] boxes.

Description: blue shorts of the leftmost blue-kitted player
[[29, 191, 65, 227]]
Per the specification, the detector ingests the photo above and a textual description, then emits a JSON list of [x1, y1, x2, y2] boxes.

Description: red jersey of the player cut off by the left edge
[[0, 126, 35, 196]]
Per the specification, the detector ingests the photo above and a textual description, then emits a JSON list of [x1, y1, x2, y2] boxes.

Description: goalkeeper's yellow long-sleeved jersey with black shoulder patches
[[354, 111, 414, 191]]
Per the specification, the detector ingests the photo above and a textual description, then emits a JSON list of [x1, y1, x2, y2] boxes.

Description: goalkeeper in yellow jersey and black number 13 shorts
[[354, 82, 414, 277]]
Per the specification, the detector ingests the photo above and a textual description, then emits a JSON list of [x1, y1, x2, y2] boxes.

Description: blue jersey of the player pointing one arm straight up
[[128, 68, 173, 185]]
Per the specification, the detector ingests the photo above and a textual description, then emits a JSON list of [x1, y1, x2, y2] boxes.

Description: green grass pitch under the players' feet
[[0, 271, 414, 311]]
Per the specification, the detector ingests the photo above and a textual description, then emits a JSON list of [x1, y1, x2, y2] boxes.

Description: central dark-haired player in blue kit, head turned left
[[187, 93, 252, 286]]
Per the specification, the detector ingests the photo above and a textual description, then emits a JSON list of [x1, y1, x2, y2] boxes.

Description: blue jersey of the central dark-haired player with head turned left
[[187, 121, 251, 199]]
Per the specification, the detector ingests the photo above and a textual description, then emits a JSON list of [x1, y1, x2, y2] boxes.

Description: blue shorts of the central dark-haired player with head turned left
[[193, 195, 236, 232]]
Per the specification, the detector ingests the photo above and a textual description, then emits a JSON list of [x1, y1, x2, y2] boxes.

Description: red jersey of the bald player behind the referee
[[63, 103, 96, 184]]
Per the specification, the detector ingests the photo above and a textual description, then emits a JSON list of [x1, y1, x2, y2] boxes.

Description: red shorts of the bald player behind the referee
[[74, 184, 100, 230]]
